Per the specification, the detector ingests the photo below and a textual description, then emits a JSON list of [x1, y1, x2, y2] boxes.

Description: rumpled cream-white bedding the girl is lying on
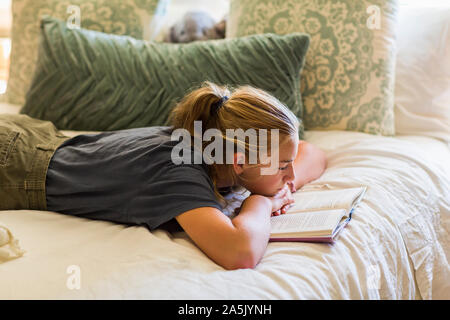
[[0, 104, 450, 300]]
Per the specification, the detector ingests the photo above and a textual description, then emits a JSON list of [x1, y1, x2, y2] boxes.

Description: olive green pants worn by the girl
[[0, 114, 70, 210]]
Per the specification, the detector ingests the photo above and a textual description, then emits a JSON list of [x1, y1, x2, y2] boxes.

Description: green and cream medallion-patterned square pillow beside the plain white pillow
[[227, 0, 397, 135]]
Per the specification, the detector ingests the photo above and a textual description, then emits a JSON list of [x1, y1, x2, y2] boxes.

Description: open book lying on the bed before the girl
[[270, 186, 367, 242]]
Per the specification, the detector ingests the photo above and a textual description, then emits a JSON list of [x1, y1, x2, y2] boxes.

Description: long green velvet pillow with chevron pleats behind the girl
[[21, 17, 309, 136]]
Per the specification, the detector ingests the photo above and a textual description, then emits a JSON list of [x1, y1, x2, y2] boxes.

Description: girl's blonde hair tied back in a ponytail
[[169, 82, 301, 202]]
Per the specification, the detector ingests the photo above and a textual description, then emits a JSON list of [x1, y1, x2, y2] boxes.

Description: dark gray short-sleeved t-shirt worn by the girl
[[46, 126, 222, 230]]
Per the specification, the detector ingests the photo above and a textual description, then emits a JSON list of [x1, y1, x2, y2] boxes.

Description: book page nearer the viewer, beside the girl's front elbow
[[270, 209, 346, 235]]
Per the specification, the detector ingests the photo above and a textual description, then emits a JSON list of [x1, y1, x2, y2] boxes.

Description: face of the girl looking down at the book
[[235, 137, 299, 196]]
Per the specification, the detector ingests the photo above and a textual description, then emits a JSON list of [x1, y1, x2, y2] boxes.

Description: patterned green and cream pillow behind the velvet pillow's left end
[[7, 0, 158, 105]]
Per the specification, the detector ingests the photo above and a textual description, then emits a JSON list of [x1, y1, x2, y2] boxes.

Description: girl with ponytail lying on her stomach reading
[[0, 83, 327, 269]]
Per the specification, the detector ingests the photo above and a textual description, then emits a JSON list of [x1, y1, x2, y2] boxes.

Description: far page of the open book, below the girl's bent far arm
[[288, 187, 366, 213]]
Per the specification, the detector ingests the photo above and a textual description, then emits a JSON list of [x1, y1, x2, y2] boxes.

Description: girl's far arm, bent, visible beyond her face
[[294, 140, 327, 189]]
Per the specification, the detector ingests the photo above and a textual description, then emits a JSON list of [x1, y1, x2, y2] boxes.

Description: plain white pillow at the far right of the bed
[[395, 6, 450, 145]]
